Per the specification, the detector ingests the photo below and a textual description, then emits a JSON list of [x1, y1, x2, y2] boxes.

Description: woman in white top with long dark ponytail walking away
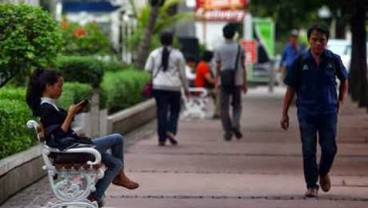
[[144, 32, 189, 146]]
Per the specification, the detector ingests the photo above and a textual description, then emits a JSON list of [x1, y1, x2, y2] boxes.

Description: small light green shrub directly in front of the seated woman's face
[[58, 82, 92, 110]]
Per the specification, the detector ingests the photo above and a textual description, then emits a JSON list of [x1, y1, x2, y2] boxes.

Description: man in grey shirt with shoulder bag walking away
[[215, 24, 248, 141]]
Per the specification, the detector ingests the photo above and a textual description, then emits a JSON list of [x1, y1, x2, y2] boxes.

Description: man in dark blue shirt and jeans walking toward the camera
[[280, 24, 348, 197]]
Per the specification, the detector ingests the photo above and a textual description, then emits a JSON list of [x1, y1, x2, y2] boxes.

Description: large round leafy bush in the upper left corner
[[0, 4, 62, 87]]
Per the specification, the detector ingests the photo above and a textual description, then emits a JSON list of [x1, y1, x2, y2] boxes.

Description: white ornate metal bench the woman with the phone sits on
[[27, 120, 104, 208]]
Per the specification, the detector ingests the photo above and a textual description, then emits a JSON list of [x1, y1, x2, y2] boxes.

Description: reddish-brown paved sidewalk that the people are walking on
[[3, 87, 368, 208]]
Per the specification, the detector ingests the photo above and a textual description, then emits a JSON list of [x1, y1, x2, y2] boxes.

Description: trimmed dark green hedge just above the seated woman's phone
[[57, 56, 104, 88]]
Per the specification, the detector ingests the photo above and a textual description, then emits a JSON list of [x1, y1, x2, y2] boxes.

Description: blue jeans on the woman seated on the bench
[[93, 134, 124, 200]]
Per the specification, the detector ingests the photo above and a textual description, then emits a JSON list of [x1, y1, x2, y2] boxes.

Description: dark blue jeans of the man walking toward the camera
[[298, 111, 337, 188]]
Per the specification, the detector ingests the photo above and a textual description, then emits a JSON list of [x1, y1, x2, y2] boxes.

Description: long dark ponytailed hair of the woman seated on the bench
[[26, 69, 61, 116]]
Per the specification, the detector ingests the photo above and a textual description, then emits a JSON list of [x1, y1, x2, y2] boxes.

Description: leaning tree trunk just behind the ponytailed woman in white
[[135, 5, 159, 69]]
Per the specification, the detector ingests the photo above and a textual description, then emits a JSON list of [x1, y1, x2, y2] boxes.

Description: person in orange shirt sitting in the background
[[194, 51, 220, 118]]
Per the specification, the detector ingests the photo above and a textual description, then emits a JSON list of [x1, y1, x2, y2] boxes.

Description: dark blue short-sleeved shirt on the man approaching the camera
[[284, 49, 347, 114]]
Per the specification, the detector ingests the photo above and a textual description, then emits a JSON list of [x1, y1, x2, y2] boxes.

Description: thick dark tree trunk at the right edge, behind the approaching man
[[349, 0, 368, 106]]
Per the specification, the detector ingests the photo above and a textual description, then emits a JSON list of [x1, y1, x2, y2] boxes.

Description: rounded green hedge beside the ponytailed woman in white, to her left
[[101, 70, 150, 114]]
